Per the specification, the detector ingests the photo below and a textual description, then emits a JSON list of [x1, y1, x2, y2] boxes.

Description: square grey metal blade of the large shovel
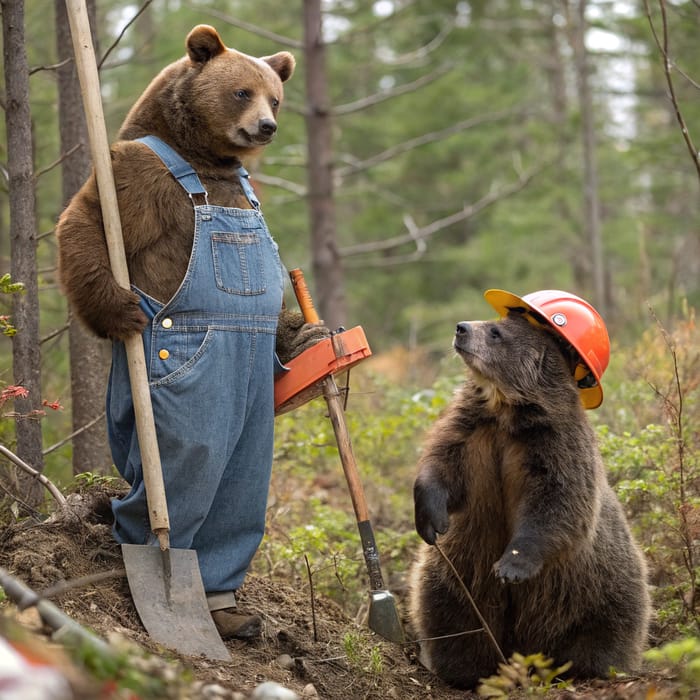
[[121, 544, 231, 661]]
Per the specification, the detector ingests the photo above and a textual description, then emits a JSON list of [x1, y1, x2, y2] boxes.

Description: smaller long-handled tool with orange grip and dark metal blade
[[289, 269, 405, 643]]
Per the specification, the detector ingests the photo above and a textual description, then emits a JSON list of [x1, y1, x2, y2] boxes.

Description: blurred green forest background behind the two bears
[[0, 0, 700, 688]]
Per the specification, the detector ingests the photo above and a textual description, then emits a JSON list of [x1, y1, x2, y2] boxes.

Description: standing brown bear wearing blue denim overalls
[[57, 25, 329, 636]]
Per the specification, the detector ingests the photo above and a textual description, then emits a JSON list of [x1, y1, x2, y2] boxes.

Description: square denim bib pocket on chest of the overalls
[[211, 229, 265, 296]]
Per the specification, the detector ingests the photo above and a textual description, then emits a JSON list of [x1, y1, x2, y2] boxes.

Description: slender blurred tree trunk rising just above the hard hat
[[572, 0, 608, 317]]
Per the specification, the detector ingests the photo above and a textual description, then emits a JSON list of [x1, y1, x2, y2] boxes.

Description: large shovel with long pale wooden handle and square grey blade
[[66, 0, 226, 661]]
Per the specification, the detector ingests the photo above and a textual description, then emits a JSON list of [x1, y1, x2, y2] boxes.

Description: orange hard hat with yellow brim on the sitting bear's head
[[484, 289, 610, 408]]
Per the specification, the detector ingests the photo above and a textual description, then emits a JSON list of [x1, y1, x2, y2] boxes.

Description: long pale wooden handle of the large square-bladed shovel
[[66, 0, 170, 550]]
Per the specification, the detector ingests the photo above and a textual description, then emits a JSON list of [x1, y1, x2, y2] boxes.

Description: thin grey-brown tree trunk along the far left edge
[[0, 0, 44, 507]]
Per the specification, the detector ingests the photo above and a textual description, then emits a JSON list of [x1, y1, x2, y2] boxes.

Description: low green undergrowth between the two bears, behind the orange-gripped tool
[[253, 370, 454, 611]]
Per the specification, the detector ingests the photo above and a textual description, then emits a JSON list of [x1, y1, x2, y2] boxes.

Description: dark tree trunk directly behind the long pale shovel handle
[[55, 0, 112, 474]]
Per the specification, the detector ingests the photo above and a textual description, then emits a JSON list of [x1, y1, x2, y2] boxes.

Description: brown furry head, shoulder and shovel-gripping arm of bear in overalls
[[57, 25, 295, 340]]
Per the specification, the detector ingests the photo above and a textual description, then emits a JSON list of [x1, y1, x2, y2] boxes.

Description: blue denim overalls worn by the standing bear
[[107, 136, 285, 593]]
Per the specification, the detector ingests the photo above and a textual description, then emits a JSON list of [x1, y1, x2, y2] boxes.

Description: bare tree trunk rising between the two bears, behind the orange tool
[[304, 0, 346, 328]]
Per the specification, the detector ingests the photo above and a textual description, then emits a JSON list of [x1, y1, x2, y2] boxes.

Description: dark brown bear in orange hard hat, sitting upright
[[409, 290, 650, 687]]
